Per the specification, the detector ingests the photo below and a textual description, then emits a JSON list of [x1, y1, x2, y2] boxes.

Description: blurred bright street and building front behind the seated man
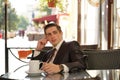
[[0, 0, 120, 74]]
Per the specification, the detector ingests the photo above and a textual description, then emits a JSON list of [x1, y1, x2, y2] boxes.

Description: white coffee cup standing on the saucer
[[29, 60, 43, 73]]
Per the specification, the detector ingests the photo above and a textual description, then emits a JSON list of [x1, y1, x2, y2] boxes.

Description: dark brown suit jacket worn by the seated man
[[33, 41, 86, 72]]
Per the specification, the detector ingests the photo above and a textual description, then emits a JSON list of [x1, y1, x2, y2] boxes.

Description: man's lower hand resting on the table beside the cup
[[41, 63, 61, 74]]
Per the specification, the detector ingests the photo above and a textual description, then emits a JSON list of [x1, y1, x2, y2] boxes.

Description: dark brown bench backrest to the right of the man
[[83, 49, 120, 69]]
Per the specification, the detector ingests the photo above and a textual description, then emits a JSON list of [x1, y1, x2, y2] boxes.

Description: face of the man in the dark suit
[[46, 26, 62, 46]]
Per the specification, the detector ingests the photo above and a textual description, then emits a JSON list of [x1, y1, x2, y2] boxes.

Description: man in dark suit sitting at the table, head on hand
[[33, 23, 86, 74]]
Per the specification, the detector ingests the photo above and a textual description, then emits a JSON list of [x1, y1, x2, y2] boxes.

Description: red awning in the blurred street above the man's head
[[33, 15, 57, 23]]
